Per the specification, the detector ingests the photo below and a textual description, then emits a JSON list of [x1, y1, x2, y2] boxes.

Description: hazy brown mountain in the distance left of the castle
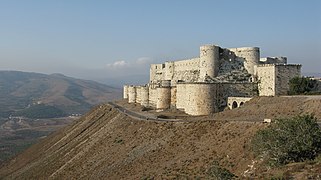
[[0, 71, 121, 118]]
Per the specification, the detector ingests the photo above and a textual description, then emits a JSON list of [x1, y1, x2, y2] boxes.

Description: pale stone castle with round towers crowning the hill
[[123, 45, 301, 115]]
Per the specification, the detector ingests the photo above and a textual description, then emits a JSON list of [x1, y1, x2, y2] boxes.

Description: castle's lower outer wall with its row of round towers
[[124, 82, 258, 115]]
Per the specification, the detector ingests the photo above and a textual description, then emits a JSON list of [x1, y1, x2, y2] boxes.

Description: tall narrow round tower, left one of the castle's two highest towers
[[199, 45, 220, 81]]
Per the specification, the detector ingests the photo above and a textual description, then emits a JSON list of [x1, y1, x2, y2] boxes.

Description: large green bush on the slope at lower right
[[252, 115, 321, 165]]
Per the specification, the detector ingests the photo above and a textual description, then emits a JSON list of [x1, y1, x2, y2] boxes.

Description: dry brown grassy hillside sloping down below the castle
[[0, 96, 321, 179]]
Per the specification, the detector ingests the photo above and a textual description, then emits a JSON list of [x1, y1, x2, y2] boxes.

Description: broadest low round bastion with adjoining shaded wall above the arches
[[176, 83, 257, 115]]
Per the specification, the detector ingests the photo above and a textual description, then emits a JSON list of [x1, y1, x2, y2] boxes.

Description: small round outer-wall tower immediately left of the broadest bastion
[[156, 87, 171, 109]]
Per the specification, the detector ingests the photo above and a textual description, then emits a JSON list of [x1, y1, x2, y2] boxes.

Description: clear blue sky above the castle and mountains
[[0, 0, 321, 85]]
